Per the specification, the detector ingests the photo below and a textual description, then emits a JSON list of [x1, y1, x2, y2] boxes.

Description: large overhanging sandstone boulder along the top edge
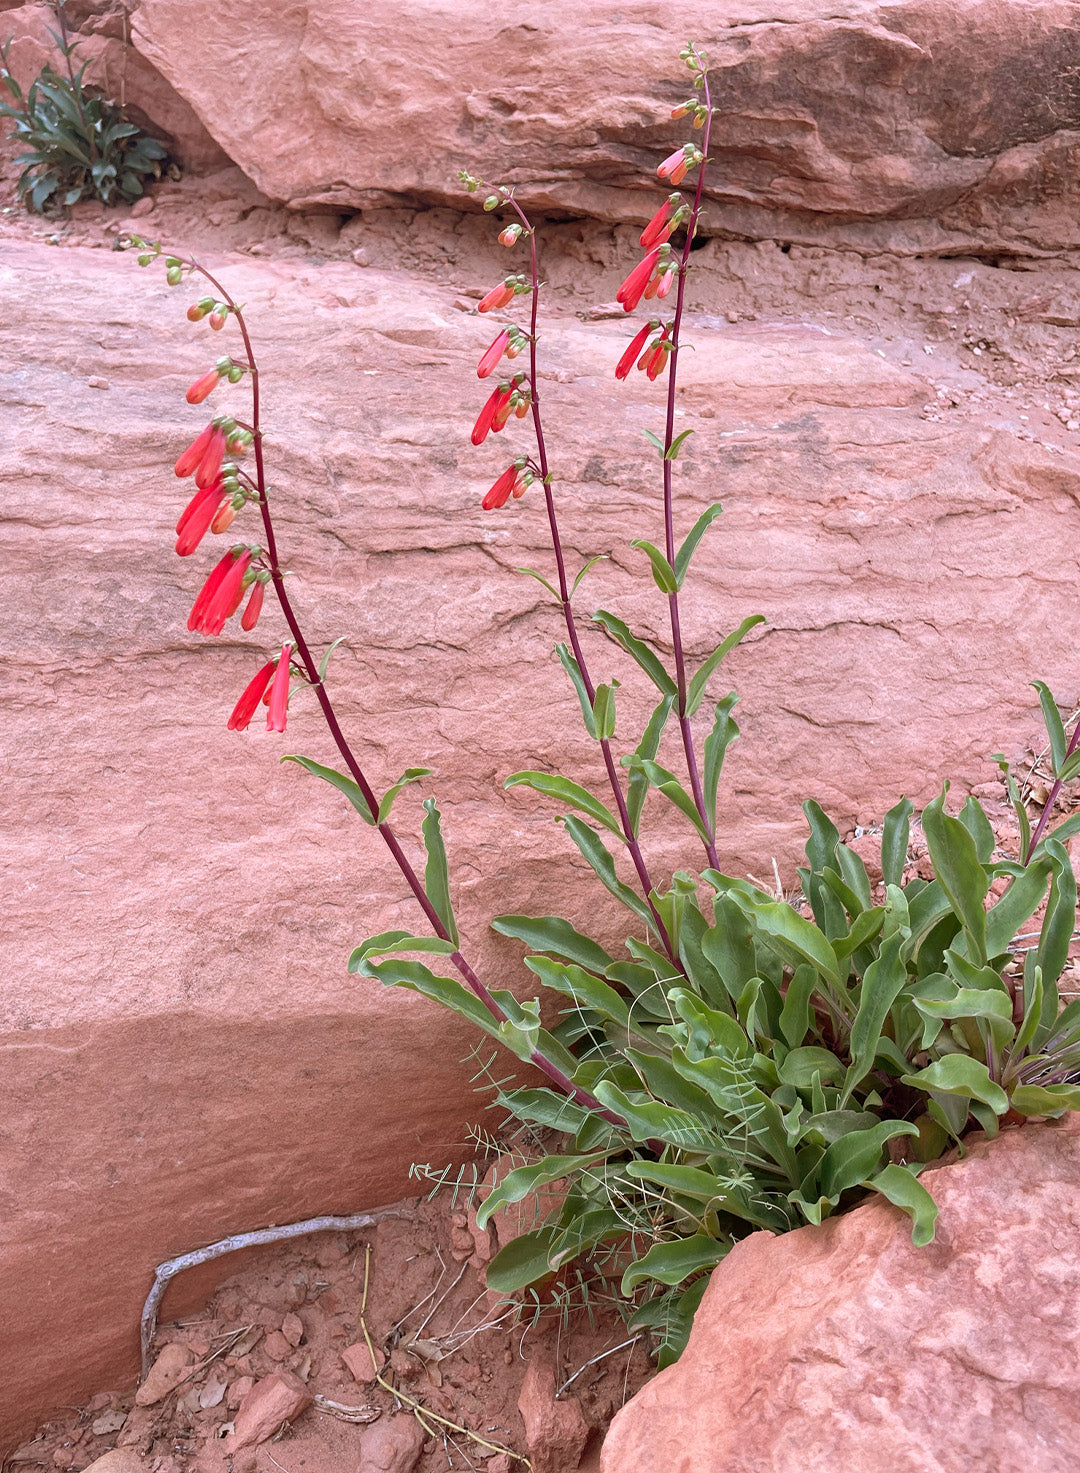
[[133, 0, 1080, 255]]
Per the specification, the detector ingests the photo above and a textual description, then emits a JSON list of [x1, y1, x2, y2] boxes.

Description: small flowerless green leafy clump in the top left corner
[[0, 12, 168, 215]]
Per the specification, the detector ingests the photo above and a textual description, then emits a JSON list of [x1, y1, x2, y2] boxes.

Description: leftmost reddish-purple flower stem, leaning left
[[174, 259, 626, 1130]]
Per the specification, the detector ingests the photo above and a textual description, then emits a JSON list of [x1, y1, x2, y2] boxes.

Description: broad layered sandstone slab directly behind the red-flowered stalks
[[0, 229, 1080, 1442]]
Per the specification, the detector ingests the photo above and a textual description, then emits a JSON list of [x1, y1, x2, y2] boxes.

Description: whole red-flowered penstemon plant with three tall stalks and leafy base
[[133, 37, 1080, 1363]]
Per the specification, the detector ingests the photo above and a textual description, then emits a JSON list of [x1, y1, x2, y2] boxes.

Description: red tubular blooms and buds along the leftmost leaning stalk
[[131, 236, 293, 732]]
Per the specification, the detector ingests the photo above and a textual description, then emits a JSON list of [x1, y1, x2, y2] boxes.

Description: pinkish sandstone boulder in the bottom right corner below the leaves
[[601, 1121, 1080, 1473]]
